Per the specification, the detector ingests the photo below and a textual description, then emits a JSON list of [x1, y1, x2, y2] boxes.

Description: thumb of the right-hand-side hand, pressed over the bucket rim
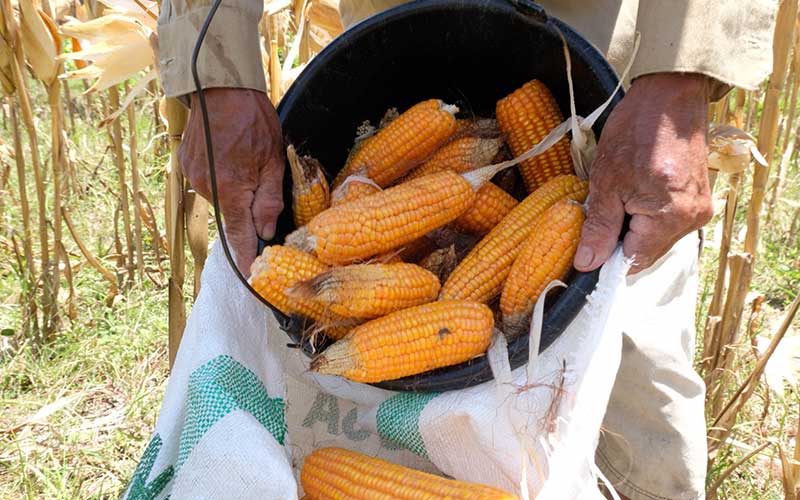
[[574, 190, 625, 272]]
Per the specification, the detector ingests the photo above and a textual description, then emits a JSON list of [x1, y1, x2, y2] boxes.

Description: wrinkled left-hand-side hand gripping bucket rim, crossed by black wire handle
[[179, 88, 284, 276]]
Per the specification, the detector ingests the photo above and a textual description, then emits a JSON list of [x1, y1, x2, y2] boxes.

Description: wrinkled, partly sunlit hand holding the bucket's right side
[[575, 73, 712, 273]]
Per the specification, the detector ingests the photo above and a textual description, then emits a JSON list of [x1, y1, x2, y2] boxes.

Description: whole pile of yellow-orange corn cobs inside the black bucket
[[251, 81, 588, 382]]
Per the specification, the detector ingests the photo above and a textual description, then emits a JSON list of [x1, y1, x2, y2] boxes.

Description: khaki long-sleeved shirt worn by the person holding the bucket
[[158, 0, 777, 98]]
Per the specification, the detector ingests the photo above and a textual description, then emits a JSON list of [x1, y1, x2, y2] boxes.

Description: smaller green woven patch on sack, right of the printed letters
[[377, 392, 439, 458]]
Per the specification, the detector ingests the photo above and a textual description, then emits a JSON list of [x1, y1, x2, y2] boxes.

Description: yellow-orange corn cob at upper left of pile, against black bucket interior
[[333, 99, 458, 189]]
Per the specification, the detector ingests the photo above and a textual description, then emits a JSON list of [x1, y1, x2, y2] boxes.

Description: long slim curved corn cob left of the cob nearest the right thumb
[[439, 175, 589, 302]]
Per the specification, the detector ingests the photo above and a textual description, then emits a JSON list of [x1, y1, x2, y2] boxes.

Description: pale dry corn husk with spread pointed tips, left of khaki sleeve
[[61, 14, 155, 93]]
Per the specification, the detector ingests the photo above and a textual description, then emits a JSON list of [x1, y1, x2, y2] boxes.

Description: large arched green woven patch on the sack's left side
[[175, 355, 286, 470]]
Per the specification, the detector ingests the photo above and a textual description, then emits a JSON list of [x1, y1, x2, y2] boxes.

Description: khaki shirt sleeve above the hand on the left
[[158, 0, 266, 97]]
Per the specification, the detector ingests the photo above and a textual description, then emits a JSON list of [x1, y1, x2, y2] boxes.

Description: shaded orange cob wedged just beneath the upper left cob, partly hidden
[[405, 136, 503, 180]]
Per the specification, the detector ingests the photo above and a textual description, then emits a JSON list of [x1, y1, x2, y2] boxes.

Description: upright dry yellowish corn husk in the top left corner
[[19, 0, 61, 85]]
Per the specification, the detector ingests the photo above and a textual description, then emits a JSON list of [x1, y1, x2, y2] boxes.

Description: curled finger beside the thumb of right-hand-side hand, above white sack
[[622, 214, 677, 274]]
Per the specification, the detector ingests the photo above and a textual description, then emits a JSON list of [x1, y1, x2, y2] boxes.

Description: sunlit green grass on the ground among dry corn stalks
[[0, 77, 800, 499]]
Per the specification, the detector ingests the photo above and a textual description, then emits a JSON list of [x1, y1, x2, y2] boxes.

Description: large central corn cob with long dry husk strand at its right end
[[298, 171, 475, 265]]
